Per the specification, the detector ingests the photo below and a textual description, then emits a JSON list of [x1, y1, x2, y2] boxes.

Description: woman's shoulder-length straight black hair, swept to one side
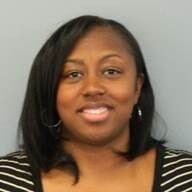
[[19, 15, 160, 182]]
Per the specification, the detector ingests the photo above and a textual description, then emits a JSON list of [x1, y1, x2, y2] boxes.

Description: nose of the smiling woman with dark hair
[[83, 76, 106, 97]]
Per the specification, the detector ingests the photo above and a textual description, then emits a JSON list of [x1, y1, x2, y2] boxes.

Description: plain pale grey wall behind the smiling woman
[[0, 0, 192, 155]]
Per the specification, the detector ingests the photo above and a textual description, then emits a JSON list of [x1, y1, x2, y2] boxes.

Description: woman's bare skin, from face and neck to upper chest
[[42, 27, 155, 192]]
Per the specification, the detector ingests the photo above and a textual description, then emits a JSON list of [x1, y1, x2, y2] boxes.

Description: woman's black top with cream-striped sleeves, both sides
[[0, 146, 192, 192]]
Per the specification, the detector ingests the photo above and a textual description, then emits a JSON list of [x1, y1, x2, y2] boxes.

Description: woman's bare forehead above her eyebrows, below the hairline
[[68, 27, 134, 57]]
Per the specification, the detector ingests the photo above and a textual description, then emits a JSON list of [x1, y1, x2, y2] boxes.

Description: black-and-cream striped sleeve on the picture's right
[[160, 148, 192, 192]]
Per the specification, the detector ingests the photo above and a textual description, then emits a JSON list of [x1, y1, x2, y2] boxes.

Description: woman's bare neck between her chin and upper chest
[[65, 134, 128, 176]]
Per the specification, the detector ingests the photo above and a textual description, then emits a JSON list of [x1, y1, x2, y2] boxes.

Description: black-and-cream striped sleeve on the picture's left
[[0, 151, 34, 192]]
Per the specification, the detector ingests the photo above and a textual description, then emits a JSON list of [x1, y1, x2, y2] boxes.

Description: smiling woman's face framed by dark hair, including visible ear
[[57, 27, 143, 145]]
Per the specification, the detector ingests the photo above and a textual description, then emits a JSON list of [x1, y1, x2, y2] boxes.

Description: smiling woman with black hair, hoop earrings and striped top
[[0, 16, 192, 192]]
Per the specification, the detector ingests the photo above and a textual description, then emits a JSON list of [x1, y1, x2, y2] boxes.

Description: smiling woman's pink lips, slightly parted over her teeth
[[77, 104, 112, 123]]
